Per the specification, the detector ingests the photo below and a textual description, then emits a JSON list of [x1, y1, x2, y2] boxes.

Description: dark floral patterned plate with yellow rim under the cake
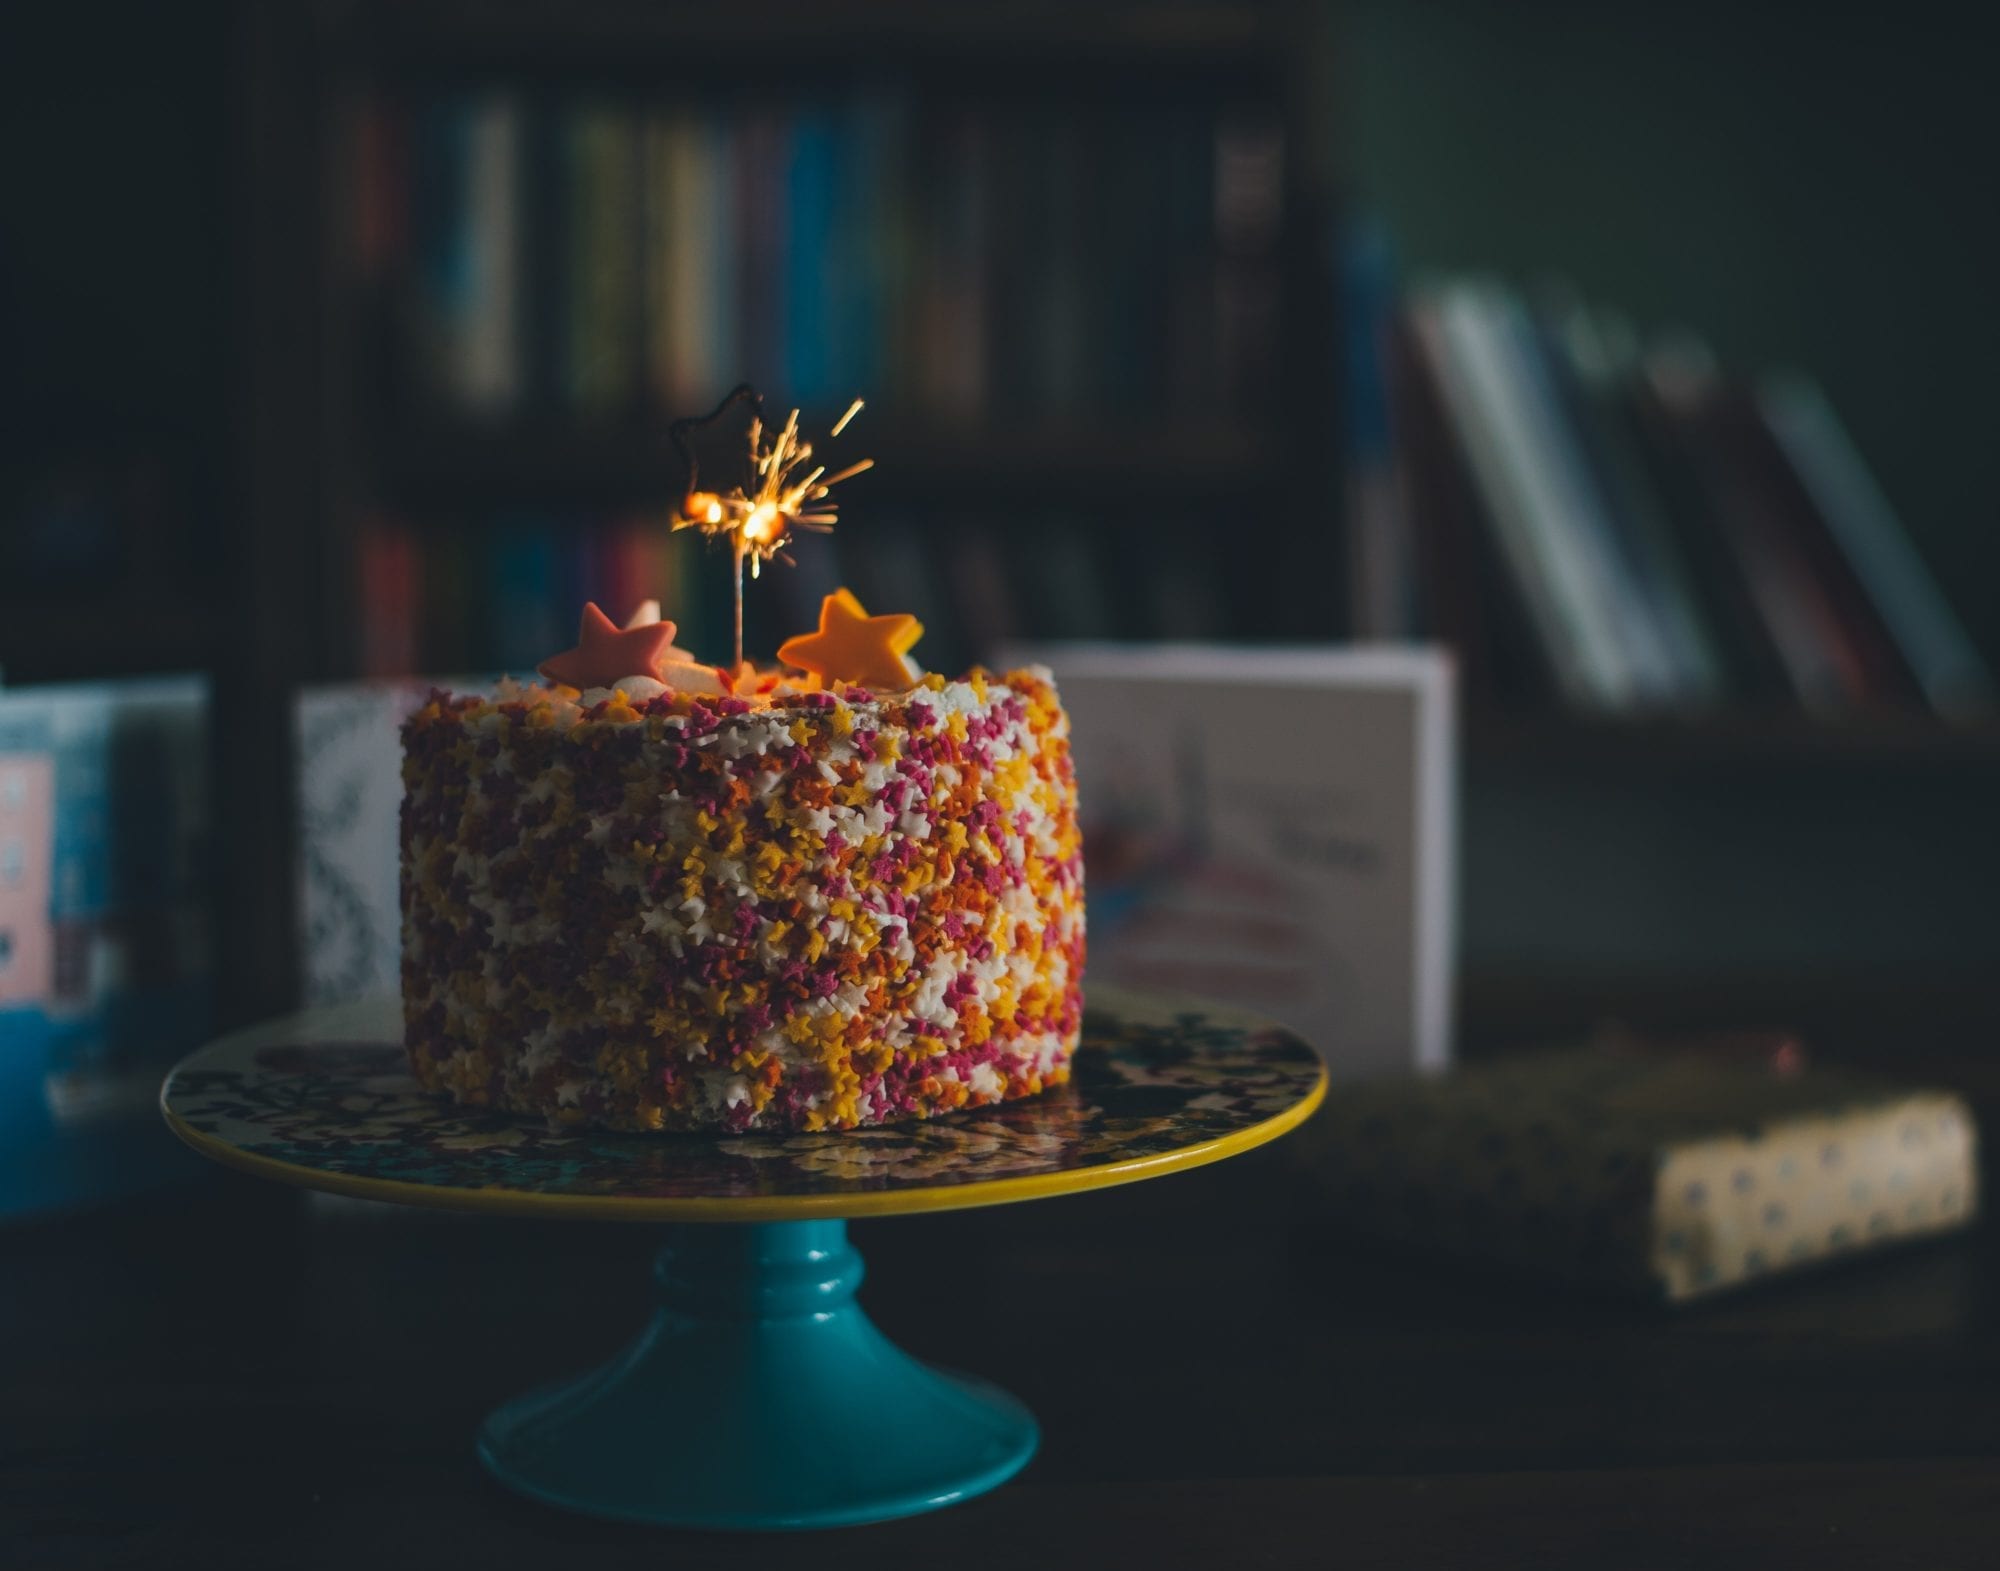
[[160, 987, 1326, 1221]]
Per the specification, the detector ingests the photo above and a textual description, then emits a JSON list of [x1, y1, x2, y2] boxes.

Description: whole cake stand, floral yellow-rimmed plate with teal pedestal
[[160, 987, 1326, 1529]]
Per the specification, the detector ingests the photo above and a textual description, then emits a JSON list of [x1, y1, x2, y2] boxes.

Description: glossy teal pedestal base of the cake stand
[[480, 1221, 1038, 1529]]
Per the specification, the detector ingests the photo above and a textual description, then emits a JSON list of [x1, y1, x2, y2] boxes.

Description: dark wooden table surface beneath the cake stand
[[0, 1103, 2000, 1571]]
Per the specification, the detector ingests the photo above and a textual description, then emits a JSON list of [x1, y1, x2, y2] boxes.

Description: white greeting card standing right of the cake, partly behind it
[[1010, 644, 1456, 1075]]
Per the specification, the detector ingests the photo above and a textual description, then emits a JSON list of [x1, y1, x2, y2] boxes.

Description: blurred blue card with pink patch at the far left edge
[[0, 678, 214, 1217]]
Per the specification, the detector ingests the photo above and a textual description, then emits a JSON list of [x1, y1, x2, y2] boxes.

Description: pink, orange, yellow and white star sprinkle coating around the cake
[[402, 668, 1084, 1131]]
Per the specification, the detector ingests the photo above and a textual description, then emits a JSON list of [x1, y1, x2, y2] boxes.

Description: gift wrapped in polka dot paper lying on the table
[[1294, 1049, 1978, 1301]]
